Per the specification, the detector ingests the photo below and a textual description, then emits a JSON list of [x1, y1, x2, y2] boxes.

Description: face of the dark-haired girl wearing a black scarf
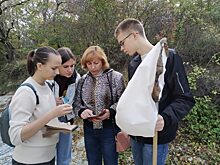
[[59, 58, 76, 78]]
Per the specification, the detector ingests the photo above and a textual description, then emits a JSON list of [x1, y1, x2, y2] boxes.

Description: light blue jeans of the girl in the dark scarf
[[56, 116, 73, 165]]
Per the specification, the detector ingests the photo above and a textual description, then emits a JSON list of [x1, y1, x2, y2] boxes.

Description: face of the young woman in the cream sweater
[[38, 55, 62, 80]]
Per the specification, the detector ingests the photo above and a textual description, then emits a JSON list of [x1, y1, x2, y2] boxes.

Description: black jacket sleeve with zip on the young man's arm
[[160, 54, 195, 127]]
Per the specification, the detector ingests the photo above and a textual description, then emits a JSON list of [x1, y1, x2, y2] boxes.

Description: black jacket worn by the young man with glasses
[[128, 49, 195, 144]]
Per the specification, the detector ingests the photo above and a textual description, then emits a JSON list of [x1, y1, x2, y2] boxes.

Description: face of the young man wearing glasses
[[117, 32, 136, 56]]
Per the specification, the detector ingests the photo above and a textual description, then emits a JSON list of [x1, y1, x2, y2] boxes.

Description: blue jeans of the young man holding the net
[[131, 138, 168, 165]]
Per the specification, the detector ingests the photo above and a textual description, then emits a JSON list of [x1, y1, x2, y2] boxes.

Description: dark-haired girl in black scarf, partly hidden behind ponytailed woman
[[48, 47, 80, 165]]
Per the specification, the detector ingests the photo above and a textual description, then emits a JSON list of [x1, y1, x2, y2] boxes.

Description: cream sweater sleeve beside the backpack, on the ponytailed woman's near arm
[[9, 86, 36, 146]]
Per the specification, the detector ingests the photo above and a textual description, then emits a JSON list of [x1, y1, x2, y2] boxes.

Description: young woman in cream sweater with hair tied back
[[9, 46, 72, 165]]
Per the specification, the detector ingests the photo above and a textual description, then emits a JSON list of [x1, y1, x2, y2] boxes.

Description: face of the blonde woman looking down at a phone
[[86, 58, 103, 76]]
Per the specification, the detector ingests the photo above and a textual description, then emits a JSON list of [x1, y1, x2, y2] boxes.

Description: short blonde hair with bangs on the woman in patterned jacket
[[81, 46, 109, 70]]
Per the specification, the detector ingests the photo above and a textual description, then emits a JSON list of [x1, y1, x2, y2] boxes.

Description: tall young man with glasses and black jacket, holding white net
[[114, 18, 195, 165]]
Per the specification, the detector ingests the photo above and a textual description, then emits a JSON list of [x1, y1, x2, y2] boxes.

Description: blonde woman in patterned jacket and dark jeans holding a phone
[[74, 46, 125, 165]]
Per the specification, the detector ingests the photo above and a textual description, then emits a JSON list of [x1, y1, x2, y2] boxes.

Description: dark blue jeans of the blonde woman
[[84, 125, 118, 165]]
